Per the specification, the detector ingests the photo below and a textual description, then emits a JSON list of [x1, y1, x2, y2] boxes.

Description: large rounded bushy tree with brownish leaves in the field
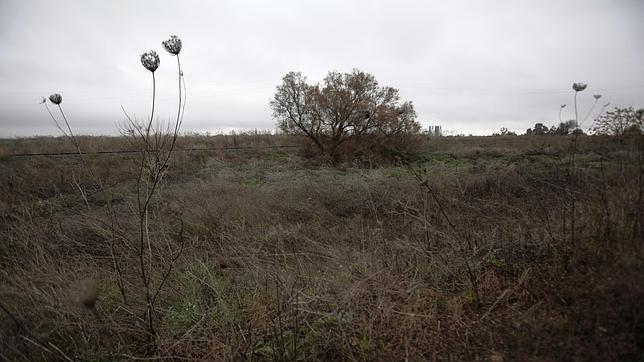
[[270, 69, 420, 161]]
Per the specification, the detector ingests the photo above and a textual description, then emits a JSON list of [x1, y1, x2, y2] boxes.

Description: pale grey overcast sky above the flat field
[[0, 0, 644, 137]]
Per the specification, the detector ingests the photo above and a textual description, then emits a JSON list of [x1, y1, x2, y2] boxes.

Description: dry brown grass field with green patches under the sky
[[0, 134, 644, 361]]
